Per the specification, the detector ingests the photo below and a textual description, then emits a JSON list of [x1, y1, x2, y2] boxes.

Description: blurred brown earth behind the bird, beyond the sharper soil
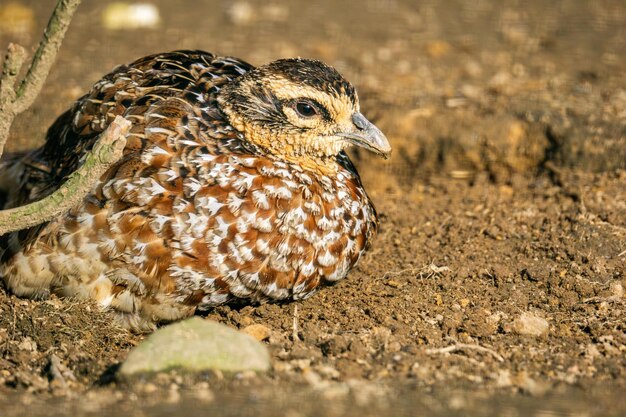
[[0, 0, 626, 193]]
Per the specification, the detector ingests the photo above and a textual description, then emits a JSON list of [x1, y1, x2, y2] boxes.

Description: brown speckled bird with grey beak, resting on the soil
[[0, 50, 391, 333]]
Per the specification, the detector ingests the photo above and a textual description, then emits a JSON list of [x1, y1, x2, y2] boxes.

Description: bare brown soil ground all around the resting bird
[[0, 0, 626, 416]]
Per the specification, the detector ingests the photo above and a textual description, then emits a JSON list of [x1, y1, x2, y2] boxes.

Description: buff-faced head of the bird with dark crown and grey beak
[[218, 58, 391, 171]]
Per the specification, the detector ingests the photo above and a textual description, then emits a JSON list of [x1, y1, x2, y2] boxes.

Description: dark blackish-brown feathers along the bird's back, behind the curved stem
[[8, 51, 252, 205]]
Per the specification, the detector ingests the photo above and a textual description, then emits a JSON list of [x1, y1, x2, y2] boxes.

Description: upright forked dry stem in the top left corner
[[0, 0, 81, 156]]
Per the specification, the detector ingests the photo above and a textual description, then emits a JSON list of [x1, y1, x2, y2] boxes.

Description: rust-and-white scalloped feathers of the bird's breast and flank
[[73, 141, 376, 308]]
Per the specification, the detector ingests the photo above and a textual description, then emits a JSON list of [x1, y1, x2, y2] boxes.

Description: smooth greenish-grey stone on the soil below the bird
[[119, 317, 270, 376]]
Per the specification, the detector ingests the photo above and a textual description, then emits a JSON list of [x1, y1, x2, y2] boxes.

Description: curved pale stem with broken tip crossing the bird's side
[[0, 116, 131, 235]]
